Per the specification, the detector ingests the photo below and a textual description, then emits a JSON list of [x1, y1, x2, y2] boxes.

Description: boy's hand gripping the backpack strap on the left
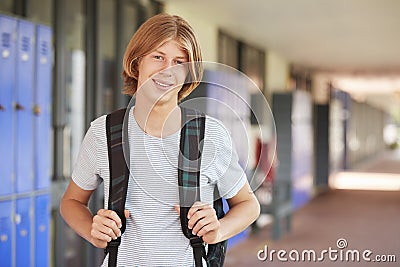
[[90, 209, 129, 248]]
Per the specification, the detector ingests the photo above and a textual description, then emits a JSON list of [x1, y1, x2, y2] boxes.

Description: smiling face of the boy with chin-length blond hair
[[138, 40, 188, 104]]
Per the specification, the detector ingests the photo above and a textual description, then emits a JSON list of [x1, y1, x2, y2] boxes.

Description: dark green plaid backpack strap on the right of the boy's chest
[[178, 107, 207, 267]]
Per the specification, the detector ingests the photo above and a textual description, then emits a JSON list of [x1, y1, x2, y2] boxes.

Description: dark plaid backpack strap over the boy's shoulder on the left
[[106, 109, 129, 267]]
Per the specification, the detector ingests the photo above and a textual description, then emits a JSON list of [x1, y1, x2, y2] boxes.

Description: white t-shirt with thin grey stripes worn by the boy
[[72, 109, 246, 266]]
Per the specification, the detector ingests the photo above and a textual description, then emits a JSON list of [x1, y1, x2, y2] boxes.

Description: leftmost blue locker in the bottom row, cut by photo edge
[[0, 201, 12, 267]]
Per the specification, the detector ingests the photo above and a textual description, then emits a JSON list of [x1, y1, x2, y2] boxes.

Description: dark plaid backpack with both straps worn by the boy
[[105, 107, 227, 267]]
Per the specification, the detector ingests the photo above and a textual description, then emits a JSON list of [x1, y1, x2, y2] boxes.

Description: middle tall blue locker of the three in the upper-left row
[[15, 20, 35, 193]]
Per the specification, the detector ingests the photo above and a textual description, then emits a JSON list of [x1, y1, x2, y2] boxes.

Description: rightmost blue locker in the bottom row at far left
[[35, 194, 50, 267]]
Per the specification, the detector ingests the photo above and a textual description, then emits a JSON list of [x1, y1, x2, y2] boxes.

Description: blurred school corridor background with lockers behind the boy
[[0, 0, 400, 266]]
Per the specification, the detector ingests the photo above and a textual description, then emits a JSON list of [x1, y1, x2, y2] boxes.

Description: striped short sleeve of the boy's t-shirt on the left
[[72, 126, 102, 190]]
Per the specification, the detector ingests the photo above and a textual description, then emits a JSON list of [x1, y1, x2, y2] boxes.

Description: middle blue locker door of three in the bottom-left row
[[15, 198, 31, 267]]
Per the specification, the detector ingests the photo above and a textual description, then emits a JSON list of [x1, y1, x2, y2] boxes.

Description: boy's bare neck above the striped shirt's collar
[[134, 99, 181, 137]]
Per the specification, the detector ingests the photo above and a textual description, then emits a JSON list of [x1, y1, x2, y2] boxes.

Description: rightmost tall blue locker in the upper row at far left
[[34, 25, 53, 189]]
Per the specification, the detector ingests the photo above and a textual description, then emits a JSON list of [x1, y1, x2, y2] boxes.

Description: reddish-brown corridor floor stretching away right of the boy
[[225, 152, 400, 267]]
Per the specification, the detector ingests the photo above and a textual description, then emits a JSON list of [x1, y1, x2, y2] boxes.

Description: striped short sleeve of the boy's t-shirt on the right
[[203, 117, 247, 199]]
